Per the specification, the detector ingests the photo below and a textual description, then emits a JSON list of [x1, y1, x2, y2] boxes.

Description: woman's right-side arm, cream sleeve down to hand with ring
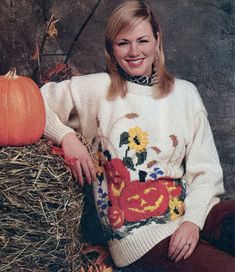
[[169, 111, 224, 261]]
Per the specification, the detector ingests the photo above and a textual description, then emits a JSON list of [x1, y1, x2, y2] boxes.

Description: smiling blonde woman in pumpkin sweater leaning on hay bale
[[42, 1, 234, 271]]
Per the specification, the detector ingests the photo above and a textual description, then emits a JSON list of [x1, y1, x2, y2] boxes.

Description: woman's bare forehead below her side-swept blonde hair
[[114, 20, 154, 40]]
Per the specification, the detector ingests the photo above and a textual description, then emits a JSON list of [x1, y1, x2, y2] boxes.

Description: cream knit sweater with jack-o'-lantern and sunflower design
[[42, 73, 224, 266]]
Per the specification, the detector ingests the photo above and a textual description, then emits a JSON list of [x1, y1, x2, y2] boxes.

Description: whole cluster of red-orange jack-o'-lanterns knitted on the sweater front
[[105, 155, 184, 229]]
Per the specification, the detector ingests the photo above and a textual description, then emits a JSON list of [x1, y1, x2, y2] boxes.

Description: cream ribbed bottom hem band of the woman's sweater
[[108, 219, 181, 267]]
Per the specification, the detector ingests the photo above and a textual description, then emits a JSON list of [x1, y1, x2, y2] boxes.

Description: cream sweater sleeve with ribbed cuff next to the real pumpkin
[[41, 80, 75, 144]]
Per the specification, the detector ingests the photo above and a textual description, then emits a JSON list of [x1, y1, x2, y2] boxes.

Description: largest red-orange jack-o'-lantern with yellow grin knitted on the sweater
[[119, 180, 169, 222]]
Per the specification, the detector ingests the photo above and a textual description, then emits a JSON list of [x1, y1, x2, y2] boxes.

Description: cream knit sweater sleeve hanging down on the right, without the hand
[[183, 110, 224, 229]]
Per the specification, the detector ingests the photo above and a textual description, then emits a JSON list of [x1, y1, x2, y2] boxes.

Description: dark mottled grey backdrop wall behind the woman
[[0, 0, 235, 198]]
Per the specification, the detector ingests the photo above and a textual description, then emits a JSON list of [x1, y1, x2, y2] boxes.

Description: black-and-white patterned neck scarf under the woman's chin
[[118, 67, 158, 86]]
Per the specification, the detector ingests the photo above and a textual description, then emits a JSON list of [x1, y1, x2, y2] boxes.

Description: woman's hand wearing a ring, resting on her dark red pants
[[168, 221, 199, 262]]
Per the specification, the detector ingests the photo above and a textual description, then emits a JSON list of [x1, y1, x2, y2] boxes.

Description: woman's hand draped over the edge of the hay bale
[[61, 132, 96, 185]]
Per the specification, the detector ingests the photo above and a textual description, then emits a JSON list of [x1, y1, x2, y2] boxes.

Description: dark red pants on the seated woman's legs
[[134, 200, 235, 272]]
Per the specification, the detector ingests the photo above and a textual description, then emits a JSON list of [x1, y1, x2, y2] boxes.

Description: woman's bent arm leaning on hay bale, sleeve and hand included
[[41, 80, 96, 185]]
